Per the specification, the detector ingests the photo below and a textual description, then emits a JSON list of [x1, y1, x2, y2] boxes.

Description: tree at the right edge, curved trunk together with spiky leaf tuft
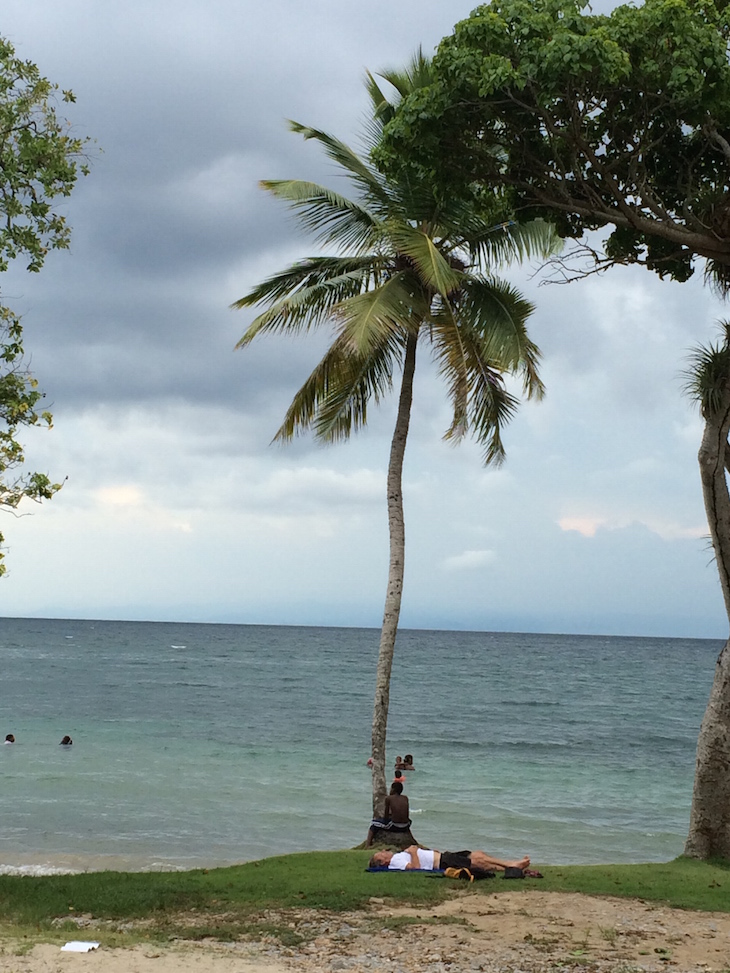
[[684, 322, 730, 859]]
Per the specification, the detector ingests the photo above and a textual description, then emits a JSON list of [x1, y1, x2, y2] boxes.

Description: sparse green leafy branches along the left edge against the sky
[[0, 38, 87, 575]]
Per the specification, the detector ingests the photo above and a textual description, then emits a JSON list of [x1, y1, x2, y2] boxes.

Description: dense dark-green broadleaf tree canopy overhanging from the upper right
[[379, 0, 730, 287]]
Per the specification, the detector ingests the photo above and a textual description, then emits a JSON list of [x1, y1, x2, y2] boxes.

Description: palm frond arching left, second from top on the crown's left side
[[260, 179, 382, 251]]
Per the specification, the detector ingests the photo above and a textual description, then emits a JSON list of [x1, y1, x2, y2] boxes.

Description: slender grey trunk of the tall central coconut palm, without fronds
[[372, 332, 418, 817]]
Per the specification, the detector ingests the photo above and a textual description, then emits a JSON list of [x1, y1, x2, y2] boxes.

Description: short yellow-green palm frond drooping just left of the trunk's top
[[337, 271, 428, 356]]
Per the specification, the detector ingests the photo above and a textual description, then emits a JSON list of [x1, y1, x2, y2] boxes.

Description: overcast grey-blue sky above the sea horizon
[[0, 0, 727, 637]]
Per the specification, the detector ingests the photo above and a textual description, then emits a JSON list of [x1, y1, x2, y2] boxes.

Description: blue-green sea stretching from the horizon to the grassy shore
[[0, 618, 722, 874]]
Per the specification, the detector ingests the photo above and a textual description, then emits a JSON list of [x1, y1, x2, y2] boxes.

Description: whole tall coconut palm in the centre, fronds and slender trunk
[[232, 52, 556, 814]]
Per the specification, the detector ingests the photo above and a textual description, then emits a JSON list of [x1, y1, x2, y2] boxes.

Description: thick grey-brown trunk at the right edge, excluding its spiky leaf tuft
[[684, 381, 730, 858]]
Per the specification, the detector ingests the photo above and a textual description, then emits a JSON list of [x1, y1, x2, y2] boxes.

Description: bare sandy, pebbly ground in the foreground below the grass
[[0, 890, 730, 973]]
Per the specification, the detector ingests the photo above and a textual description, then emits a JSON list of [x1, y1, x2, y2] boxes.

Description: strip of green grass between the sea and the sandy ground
[[0, 851, 730, 939]]
